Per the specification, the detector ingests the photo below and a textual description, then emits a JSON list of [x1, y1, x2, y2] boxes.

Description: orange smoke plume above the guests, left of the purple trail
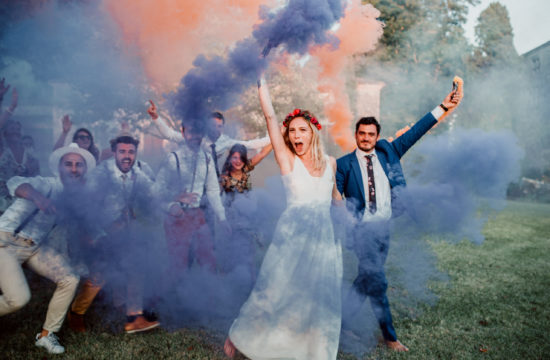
[[104, 0, 273, 92]]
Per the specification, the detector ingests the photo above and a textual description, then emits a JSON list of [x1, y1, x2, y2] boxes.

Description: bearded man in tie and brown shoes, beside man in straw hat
[[69, 134, 159, 333]]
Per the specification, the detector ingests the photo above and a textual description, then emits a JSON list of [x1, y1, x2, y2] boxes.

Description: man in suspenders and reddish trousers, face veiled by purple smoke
[[148, 102, 230, 272]]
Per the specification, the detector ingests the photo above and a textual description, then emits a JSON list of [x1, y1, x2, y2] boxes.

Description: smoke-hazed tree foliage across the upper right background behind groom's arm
[[356, 0, 550, 178]]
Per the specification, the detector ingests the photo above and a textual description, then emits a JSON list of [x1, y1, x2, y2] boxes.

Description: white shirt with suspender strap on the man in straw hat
[[0, 176, 63, 244]]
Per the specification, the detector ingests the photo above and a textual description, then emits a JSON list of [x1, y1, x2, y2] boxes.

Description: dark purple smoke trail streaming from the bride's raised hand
[[170, 0, 343, 126]]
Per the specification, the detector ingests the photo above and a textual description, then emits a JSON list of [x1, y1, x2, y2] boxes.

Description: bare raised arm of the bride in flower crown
[[258, 76, 294, 175]]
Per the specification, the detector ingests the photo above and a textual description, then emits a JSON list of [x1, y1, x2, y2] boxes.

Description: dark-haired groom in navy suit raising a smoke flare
[[336, 86, 462, 351]]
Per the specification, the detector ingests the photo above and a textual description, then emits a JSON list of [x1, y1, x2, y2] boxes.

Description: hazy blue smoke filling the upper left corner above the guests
[[0, 1, 146, 128]]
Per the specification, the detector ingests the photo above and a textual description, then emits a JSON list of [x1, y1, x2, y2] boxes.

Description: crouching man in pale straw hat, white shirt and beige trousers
[[0, 144, 95, 354]]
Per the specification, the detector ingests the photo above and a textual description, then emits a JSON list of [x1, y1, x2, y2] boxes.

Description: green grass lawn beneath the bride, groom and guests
[[0, 202, 550, 359]]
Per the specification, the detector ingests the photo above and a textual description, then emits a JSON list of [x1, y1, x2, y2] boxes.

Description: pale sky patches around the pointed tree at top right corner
[[466, 0, 550, 54]]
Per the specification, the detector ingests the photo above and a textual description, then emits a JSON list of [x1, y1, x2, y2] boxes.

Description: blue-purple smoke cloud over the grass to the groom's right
[[405, 129, 523, 243]]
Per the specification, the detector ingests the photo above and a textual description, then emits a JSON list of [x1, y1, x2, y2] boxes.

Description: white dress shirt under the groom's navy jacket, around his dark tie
[[355, 149, 391, 221]]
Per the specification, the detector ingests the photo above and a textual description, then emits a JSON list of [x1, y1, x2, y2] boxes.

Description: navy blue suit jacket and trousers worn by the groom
[[336, 113, 437, 341]]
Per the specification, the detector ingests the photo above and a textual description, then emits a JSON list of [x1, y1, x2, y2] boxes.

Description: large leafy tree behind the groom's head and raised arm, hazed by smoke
[[357, 0, 479, 135]]
